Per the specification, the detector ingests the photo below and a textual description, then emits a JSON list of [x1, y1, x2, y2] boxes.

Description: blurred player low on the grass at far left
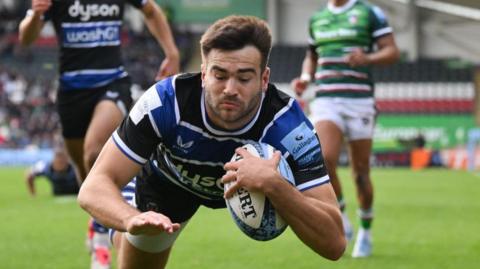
[[25, 148, 79, 196]]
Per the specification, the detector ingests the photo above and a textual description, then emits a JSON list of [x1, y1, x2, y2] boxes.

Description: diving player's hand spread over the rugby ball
[[222, 148, 281, 198]]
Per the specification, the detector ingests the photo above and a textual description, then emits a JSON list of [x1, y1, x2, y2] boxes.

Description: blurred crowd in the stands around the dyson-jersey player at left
[[0, 1, 195, 148]]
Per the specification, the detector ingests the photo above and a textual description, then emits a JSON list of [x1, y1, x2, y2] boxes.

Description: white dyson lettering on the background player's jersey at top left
[[68, 0, 120, 21]]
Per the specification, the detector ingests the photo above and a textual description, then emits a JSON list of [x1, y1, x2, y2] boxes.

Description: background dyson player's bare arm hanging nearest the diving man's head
[[142, 0, 180, 80]]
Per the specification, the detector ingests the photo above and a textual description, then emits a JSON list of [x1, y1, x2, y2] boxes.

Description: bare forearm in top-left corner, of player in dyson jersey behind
[[19, 0, 52, 46]]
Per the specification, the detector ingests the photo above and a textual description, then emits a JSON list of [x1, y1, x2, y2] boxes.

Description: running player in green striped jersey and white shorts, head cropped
[[292, 0, 399, 257]]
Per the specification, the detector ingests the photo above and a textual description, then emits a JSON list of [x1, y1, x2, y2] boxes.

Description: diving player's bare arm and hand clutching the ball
[[222, 148, 346, 260]]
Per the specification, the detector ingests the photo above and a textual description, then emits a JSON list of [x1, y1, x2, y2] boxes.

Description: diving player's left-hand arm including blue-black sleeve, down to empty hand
[[78, 79, 180, 234]]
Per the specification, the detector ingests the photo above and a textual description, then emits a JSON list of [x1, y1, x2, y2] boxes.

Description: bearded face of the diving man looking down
[[202, 46, 270, 130]]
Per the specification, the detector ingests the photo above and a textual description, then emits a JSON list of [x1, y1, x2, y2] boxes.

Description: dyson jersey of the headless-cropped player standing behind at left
[[40, 0, 146, 90]]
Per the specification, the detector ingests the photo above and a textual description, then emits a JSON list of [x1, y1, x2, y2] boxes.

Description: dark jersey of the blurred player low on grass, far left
[[30, 161, 79, 195]]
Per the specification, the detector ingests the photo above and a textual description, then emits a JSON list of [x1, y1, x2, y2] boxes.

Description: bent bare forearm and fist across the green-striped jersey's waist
[[345, 34, 400, 67]]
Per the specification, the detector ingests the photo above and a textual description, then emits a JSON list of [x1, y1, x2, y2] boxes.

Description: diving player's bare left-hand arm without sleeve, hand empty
[[78, 139, 180, 234]]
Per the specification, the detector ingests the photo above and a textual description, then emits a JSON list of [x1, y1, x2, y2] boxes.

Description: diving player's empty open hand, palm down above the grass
[[126, 211, 180, 235]]
